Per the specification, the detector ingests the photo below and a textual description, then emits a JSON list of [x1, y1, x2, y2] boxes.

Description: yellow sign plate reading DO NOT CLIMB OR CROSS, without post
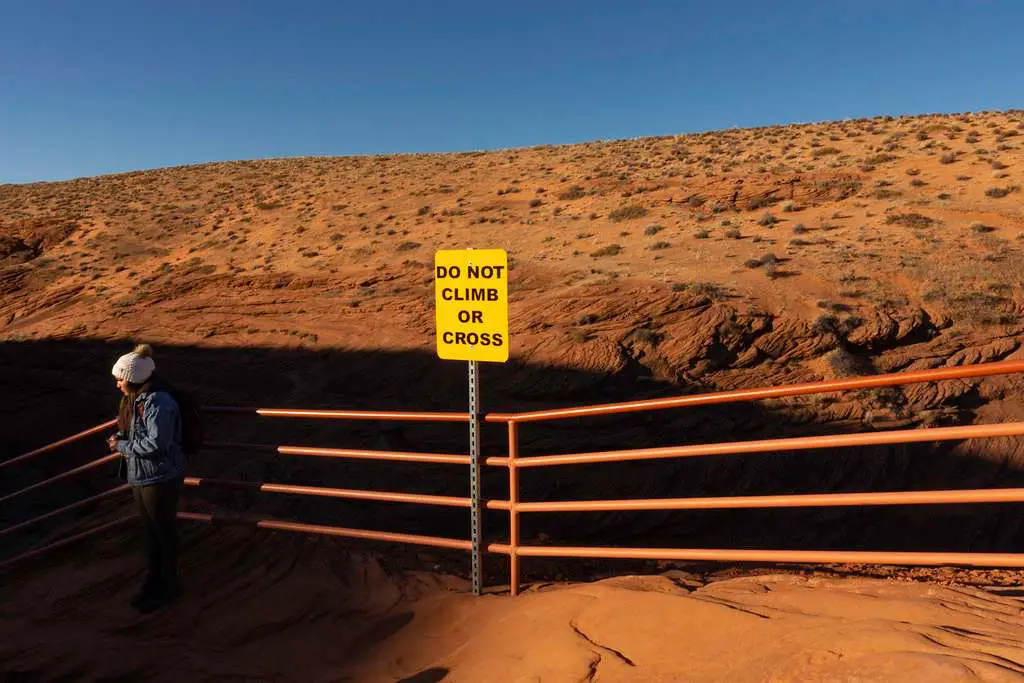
[[434, 249, 509, 362]]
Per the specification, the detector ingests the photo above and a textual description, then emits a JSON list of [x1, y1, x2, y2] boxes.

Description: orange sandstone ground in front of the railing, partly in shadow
[[0, 528, 1024, 683]]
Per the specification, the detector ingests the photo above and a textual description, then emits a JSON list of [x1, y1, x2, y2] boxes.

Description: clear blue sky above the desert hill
[[0, 0, 1024, 182]]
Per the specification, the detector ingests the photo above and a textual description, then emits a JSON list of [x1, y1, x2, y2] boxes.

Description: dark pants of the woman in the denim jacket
[[131, 479, 181, 591]]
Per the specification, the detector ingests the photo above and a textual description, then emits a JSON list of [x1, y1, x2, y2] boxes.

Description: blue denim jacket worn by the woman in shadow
[[117, 391, 185, 485]]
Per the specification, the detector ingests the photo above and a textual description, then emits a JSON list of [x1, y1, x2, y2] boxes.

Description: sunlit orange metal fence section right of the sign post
[[485, 361, 1024, 595]]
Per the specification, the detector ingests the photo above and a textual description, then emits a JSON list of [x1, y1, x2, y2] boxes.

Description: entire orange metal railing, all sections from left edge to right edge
[[6, 361, 1024, 594]]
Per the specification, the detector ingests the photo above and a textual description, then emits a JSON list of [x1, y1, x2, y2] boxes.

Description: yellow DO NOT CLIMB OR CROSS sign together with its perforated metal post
[[434, 249, 509, 595]]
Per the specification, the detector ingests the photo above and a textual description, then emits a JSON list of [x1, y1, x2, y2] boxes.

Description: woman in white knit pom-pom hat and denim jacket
[[108, 344, 184, 611]]
